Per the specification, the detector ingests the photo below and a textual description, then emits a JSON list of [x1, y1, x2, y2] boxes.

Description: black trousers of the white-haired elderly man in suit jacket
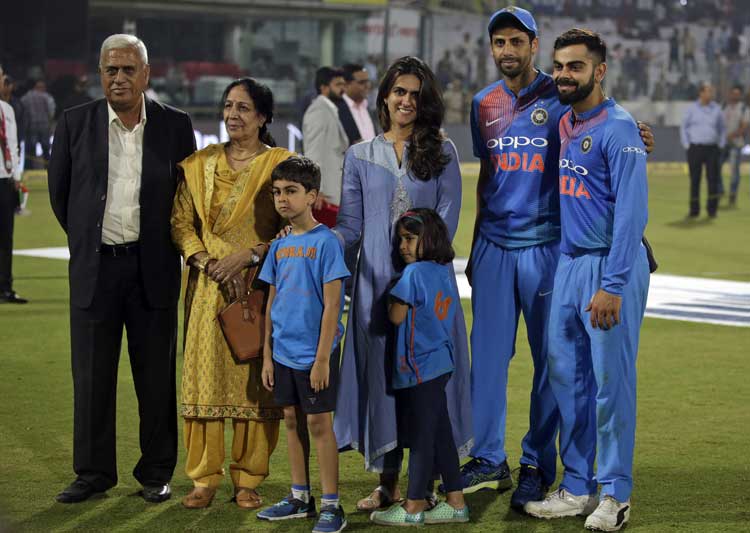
[[70, 253, 177, 490]]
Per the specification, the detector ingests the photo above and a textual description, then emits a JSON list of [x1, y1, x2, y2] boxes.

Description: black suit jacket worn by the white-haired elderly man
[[47, 98, 195, 308]]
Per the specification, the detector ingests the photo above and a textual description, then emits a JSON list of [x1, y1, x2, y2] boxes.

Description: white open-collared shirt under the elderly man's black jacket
[[102, 97, 146, 244]]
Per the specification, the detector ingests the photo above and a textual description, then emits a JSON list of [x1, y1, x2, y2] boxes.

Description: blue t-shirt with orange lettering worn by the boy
[[259, 224, 349, 370]]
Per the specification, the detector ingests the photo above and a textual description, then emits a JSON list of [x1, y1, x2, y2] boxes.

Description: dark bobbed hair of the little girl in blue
[[396, 207, 456, 265]]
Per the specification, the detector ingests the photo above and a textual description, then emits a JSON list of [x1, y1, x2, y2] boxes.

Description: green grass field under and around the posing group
[[0, 165, 750, 533]]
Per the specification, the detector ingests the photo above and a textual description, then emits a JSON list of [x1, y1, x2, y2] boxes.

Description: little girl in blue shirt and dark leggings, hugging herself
[[370, 209, 469, 525]]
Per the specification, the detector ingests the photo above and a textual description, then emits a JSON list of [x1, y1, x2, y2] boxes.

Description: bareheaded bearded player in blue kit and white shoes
[[525, 29, 649, 531]]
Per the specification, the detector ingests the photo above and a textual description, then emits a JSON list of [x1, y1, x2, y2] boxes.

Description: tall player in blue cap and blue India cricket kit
[[462, 7, 653, 509]]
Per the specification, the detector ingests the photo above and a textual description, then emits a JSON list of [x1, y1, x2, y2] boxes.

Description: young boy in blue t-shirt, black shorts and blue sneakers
[[257, 157, 349, 533]]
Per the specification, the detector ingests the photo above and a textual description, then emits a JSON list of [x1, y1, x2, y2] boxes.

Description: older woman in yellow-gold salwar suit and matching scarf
[[172, 78, 291, 509]]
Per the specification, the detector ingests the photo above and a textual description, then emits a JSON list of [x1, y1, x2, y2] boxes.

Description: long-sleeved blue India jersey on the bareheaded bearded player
[[559, 98, 648, 295]]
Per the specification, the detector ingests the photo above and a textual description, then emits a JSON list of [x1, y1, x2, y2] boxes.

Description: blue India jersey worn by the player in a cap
[[471, 72, 570, 249]]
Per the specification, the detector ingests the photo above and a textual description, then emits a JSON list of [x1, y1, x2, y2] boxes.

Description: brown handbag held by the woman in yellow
[[217, 265, 268, 361]]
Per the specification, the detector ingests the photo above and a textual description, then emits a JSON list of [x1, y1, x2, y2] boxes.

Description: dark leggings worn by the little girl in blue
[[398, 373, 463, 500]]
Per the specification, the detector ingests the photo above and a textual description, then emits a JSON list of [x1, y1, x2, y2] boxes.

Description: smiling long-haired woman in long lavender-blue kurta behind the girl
[[334, 57, 471, 510]]
